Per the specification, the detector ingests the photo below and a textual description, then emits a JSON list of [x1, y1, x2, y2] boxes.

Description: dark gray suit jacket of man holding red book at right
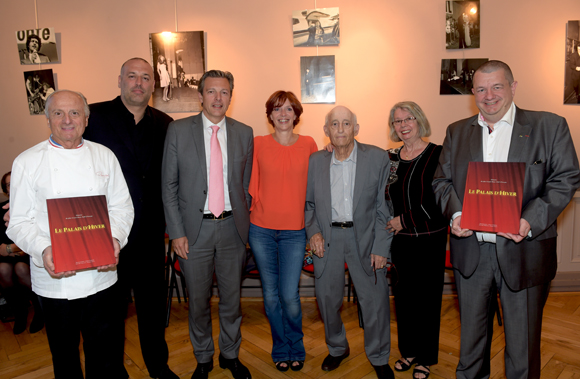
[[433, 107, 580, 291]]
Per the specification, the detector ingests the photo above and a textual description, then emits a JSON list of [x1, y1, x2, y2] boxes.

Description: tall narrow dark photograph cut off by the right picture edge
[[564, 20, 580, 104]]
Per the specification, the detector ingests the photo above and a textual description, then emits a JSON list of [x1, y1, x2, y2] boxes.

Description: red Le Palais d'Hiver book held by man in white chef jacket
[[46, 195, 116, 273]]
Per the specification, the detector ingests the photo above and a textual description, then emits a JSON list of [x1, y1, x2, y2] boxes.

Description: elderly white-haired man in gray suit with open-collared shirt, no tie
[[305, 106, 394, 378]]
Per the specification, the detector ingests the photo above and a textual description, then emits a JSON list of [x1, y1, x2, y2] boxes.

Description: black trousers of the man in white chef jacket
[[39, 284, 129, 379]]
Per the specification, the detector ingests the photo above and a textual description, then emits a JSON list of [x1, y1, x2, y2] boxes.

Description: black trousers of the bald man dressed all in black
[[117, 239, 169, 377]]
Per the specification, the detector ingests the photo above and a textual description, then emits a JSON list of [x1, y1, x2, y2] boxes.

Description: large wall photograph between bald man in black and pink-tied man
[[149, 31, 205, 113]]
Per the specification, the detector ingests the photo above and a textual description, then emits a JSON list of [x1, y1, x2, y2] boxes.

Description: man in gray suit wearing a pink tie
[[162, 70, 254, 379]]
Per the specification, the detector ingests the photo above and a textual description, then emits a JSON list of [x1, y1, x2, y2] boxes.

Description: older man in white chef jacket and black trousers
[[6, 90, 134, 378]]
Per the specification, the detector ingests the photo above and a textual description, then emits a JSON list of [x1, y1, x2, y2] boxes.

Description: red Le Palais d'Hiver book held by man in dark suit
[[461, 162, 526, 234]]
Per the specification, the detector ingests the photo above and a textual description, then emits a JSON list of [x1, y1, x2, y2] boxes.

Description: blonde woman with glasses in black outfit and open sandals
[[385, 101, 448, 379]]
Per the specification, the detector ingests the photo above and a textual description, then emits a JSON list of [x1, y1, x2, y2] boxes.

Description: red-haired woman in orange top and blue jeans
[[249, 91, 317, 371]]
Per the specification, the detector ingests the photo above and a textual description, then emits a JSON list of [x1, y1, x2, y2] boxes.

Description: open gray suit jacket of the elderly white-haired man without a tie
[[304, 142, 392, 278]]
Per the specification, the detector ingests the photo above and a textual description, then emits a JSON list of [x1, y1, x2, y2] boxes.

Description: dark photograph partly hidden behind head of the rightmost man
[[439, 58, 489, 95]]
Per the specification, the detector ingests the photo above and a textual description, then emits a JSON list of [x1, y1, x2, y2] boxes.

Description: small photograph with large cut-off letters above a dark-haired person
[[16, 28, 58, 64]]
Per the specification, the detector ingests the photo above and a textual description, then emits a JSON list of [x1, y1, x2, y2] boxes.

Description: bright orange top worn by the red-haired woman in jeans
[[249, 134, 318, 230]]
